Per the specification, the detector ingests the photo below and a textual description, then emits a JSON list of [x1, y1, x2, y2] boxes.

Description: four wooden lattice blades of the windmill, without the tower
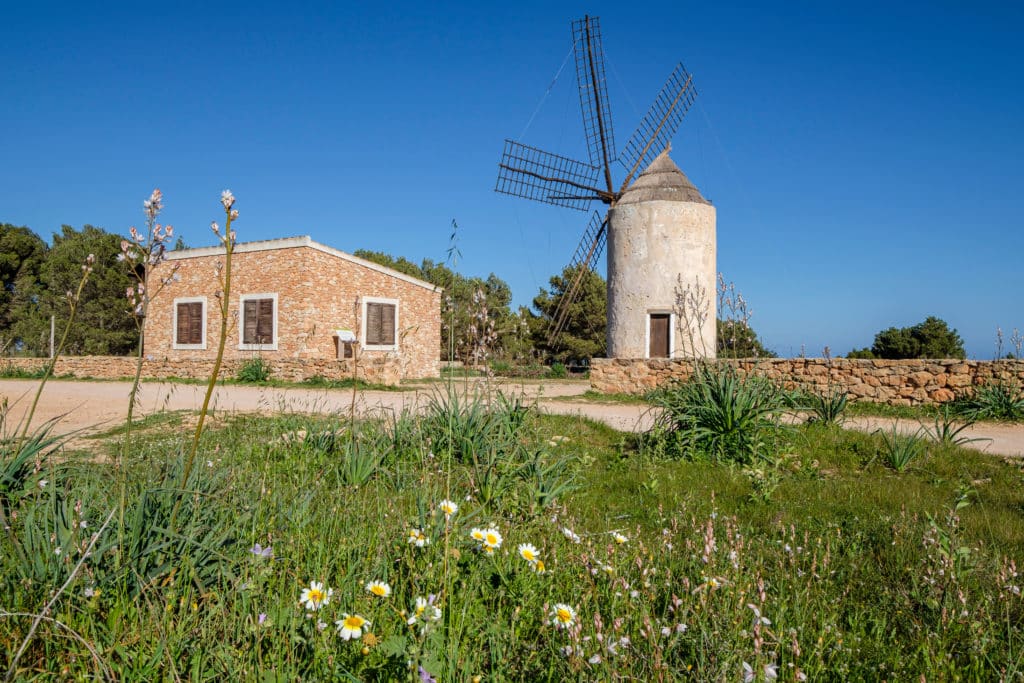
[[495, 16, 703, 358]]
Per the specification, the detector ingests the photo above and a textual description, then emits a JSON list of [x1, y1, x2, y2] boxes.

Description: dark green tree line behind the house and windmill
[[0, 223, 966, 365]]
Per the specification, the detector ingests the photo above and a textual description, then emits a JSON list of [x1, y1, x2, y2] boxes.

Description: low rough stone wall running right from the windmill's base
[[590, 358, 1024, 405]]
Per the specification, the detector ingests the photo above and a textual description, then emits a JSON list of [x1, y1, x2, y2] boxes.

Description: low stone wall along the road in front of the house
[[0, 355, 401, 386]]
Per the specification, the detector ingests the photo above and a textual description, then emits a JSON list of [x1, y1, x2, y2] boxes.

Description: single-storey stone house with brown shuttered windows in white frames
[[144, 237, 441, 379]]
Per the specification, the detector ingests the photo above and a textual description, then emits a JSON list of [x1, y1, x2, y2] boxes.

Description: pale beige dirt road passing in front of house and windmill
[[6, 380, 1024, 458]]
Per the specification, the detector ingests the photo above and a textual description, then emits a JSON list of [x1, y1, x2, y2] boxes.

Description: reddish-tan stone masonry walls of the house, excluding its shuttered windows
[[145, 238, 440, 378]]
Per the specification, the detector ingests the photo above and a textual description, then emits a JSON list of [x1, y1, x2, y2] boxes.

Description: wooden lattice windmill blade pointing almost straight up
[[572, 16, 615, 178]]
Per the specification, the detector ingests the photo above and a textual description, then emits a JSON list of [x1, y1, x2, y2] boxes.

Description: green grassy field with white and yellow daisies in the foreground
[[0, 378, 1024, 681]]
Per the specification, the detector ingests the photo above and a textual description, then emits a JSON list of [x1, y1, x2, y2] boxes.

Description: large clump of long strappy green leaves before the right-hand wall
[[650, 365, 790, 464]]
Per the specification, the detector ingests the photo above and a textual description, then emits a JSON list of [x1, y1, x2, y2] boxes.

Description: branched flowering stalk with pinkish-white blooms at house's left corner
[[118, 189, 178, 458]]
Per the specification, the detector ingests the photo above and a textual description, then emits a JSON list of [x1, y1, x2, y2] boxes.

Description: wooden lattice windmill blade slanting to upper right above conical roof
[[618, 63, 697, 185]]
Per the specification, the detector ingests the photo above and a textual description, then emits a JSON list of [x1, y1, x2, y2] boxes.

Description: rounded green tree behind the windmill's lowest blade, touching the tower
[[527, 266, 608, 364]]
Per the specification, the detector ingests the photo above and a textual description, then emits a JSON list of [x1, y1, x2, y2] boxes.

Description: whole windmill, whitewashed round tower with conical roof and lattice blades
[[495, 16, 717, 358]]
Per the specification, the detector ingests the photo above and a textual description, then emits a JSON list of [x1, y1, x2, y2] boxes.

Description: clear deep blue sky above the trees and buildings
[[0, 1, 1024, 358]]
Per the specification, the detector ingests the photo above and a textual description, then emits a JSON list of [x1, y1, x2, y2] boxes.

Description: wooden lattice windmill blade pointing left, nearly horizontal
[[495, 140, 602, 211]]
